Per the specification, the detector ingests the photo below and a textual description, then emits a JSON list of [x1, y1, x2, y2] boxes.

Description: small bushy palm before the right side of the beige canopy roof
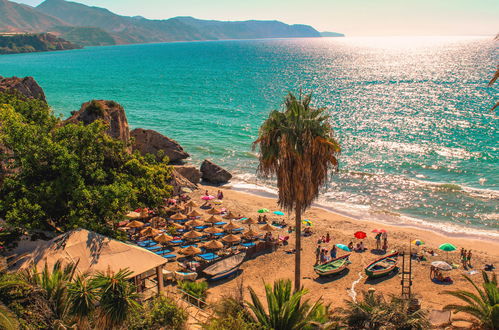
[[91, 270, 140, 329]]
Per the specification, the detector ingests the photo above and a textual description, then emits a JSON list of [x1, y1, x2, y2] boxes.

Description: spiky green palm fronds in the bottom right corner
[[442, 271, 499, 329]]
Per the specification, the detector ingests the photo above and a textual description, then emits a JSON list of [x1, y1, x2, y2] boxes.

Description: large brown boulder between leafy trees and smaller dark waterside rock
[[130, 128, 189, 163]]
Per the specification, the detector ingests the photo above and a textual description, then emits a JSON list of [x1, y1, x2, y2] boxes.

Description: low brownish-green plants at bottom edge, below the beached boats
[[340, 292, 430, 330]]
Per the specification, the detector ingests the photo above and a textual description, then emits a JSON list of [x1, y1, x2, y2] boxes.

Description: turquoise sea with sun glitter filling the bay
[[0, 37, 499, 230]]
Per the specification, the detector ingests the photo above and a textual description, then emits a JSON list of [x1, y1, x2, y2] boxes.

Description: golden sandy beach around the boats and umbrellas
[[184, 186, 499, 320]]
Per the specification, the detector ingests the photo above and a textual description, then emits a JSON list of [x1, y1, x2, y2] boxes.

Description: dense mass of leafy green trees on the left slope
[[0, 94, 171, 236]]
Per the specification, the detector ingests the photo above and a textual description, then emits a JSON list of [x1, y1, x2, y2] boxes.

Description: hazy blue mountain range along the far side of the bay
[[0, 0, 344, 46]]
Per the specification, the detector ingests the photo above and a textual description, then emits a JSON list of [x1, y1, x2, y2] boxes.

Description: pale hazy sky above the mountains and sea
[[11, 0, 499, 36]]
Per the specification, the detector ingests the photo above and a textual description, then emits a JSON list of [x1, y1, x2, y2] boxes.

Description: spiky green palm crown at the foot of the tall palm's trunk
[[247, 280, 327, 330]]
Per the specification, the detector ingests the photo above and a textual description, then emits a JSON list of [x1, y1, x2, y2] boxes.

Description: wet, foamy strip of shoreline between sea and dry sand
[[226, 180, 499, 242]]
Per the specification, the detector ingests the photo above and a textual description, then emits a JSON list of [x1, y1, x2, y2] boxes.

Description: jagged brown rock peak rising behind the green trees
[[66, 100, 130, 144]]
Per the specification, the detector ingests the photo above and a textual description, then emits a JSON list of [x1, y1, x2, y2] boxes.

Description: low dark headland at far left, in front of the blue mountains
[[0, 33, 81, 54]]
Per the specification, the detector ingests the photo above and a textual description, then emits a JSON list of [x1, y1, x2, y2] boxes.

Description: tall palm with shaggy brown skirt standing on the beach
[[253, 93, 340, 291]]
